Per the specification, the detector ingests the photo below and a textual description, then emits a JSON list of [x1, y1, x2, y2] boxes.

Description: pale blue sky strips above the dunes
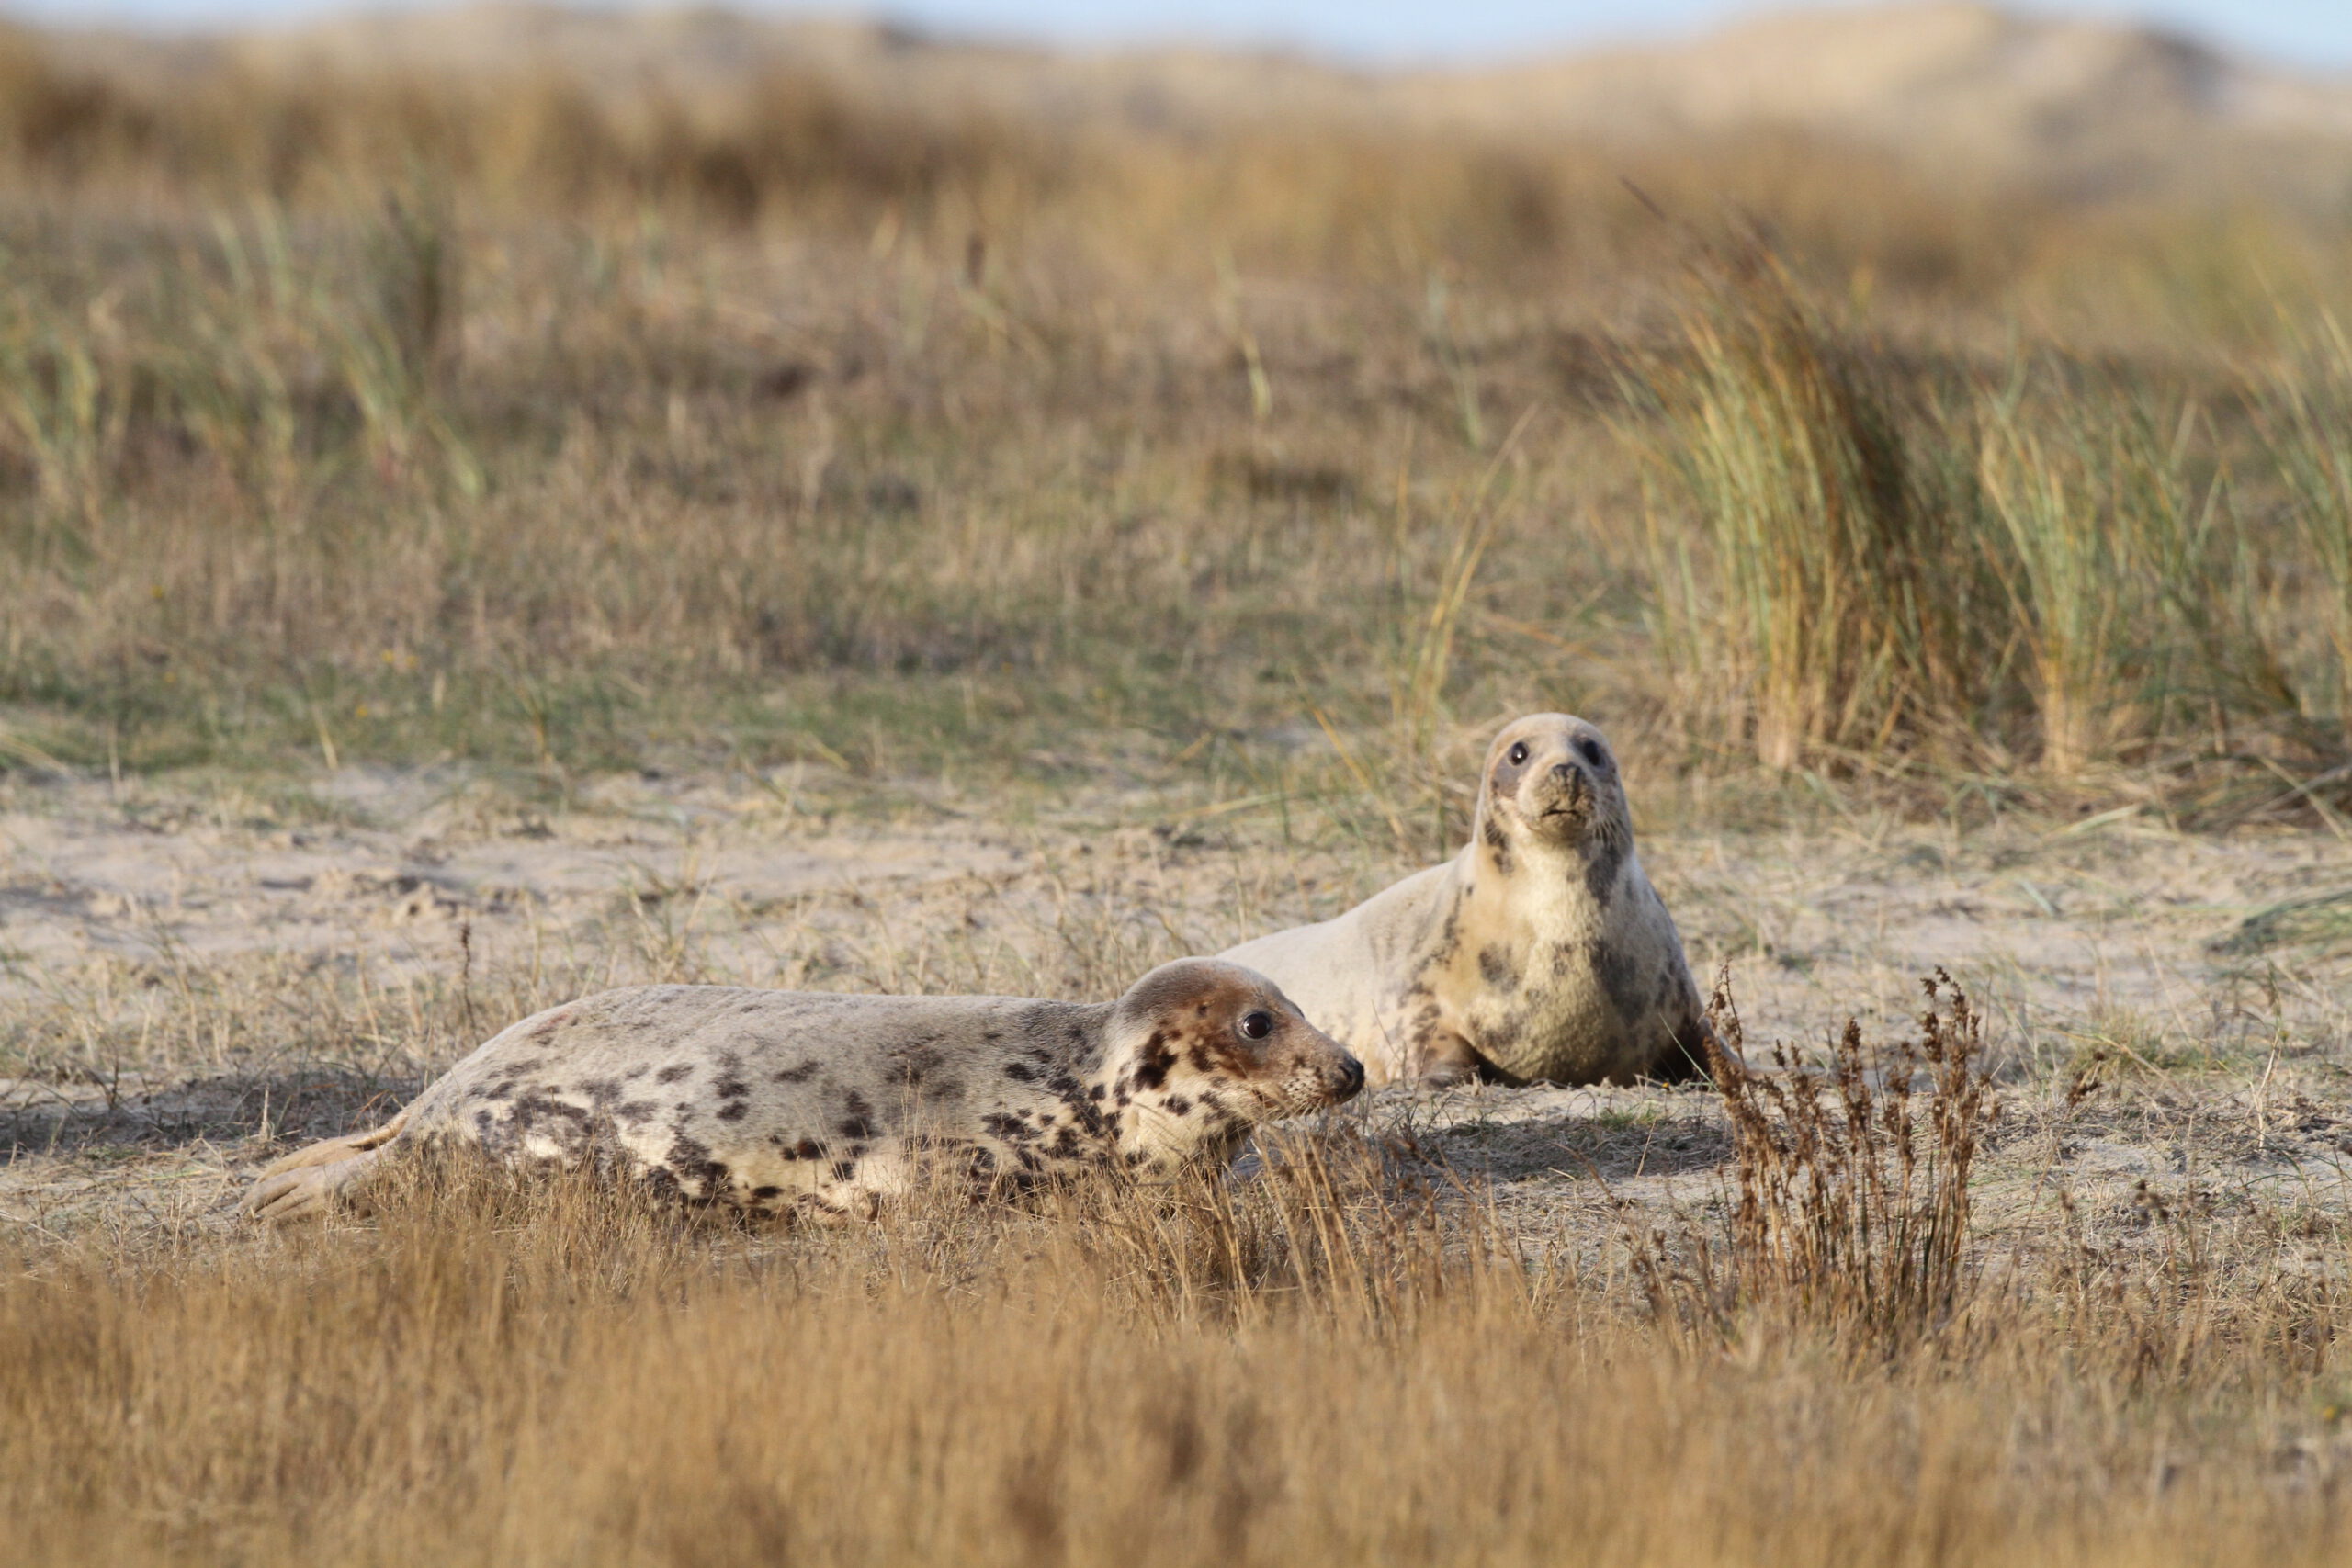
[[18, 0, 2352, 71]]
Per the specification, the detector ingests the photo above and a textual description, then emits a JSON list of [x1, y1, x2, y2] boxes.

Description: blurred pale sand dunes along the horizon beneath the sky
[[28, 0, 2352, 200]]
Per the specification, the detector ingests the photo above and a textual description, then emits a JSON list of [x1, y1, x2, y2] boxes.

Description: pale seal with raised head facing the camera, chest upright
[[1221, 712, 1708, 1084]]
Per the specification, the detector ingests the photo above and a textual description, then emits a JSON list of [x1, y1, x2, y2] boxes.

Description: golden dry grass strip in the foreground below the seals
[[14, 1053, 2345, 1563]]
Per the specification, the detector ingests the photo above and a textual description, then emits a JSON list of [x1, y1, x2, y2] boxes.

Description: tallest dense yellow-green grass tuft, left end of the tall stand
[[1634, 243, 1978, 771]]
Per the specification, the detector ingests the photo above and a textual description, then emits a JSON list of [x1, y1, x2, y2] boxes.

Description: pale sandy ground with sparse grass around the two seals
[[0, 771, 2352, 1239]]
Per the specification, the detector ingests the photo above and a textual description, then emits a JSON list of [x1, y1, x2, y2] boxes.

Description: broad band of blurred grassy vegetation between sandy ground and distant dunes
[[0, 21, 2352, 832]]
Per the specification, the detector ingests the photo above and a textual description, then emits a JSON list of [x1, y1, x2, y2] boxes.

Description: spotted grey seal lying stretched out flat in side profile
[[247, 959, 1364, 1220]]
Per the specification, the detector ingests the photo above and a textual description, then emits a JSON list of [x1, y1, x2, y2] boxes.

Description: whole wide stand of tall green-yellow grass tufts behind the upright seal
[[1628, 243, 2340, 781]]
